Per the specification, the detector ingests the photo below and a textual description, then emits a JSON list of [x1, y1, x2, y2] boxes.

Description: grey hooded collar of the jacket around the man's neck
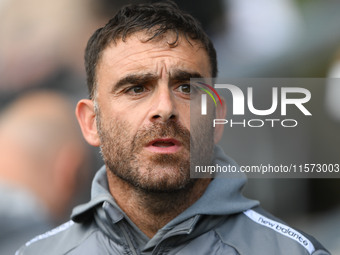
[[71, 146, 259, 225]]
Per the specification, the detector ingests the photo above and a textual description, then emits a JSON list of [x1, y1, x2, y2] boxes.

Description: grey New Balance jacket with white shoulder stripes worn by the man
[[16, 148, 329, 255]]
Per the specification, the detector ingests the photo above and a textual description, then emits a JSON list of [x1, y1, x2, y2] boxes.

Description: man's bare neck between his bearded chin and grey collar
[[107, 170, 211, 238]]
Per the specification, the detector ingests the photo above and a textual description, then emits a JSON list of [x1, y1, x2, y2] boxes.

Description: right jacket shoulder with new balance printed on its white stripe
[[216, 207, 330, 255]]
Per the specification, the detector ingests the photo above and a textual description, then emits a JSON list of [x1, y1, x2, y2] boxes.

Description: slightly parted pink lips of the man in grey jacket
[[145, 138, 182, 154]]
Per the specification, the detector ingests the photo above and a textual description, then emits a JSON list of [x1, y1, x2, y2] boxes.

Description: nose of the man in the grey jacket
[[150, 86, 178, 122]]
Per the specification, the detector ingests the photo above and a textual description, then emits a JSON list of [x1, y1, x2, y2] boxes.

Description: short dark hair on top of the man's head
[[85, 1, 217, 98]]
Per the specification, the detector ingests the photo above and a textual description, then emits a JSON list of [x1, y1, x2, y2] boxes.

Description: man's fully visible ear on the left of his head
[[76, 99, 100, 147]]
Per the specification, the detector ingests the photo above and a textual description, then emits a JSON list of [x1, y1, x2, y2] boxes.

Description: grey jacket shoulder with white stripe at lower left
[[15, 221, 98, 255]]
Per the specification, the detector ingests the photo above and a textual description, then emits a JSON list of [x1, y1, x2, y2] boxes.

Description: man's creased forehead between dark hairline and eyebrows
[[97, 32, 211, 81]]
